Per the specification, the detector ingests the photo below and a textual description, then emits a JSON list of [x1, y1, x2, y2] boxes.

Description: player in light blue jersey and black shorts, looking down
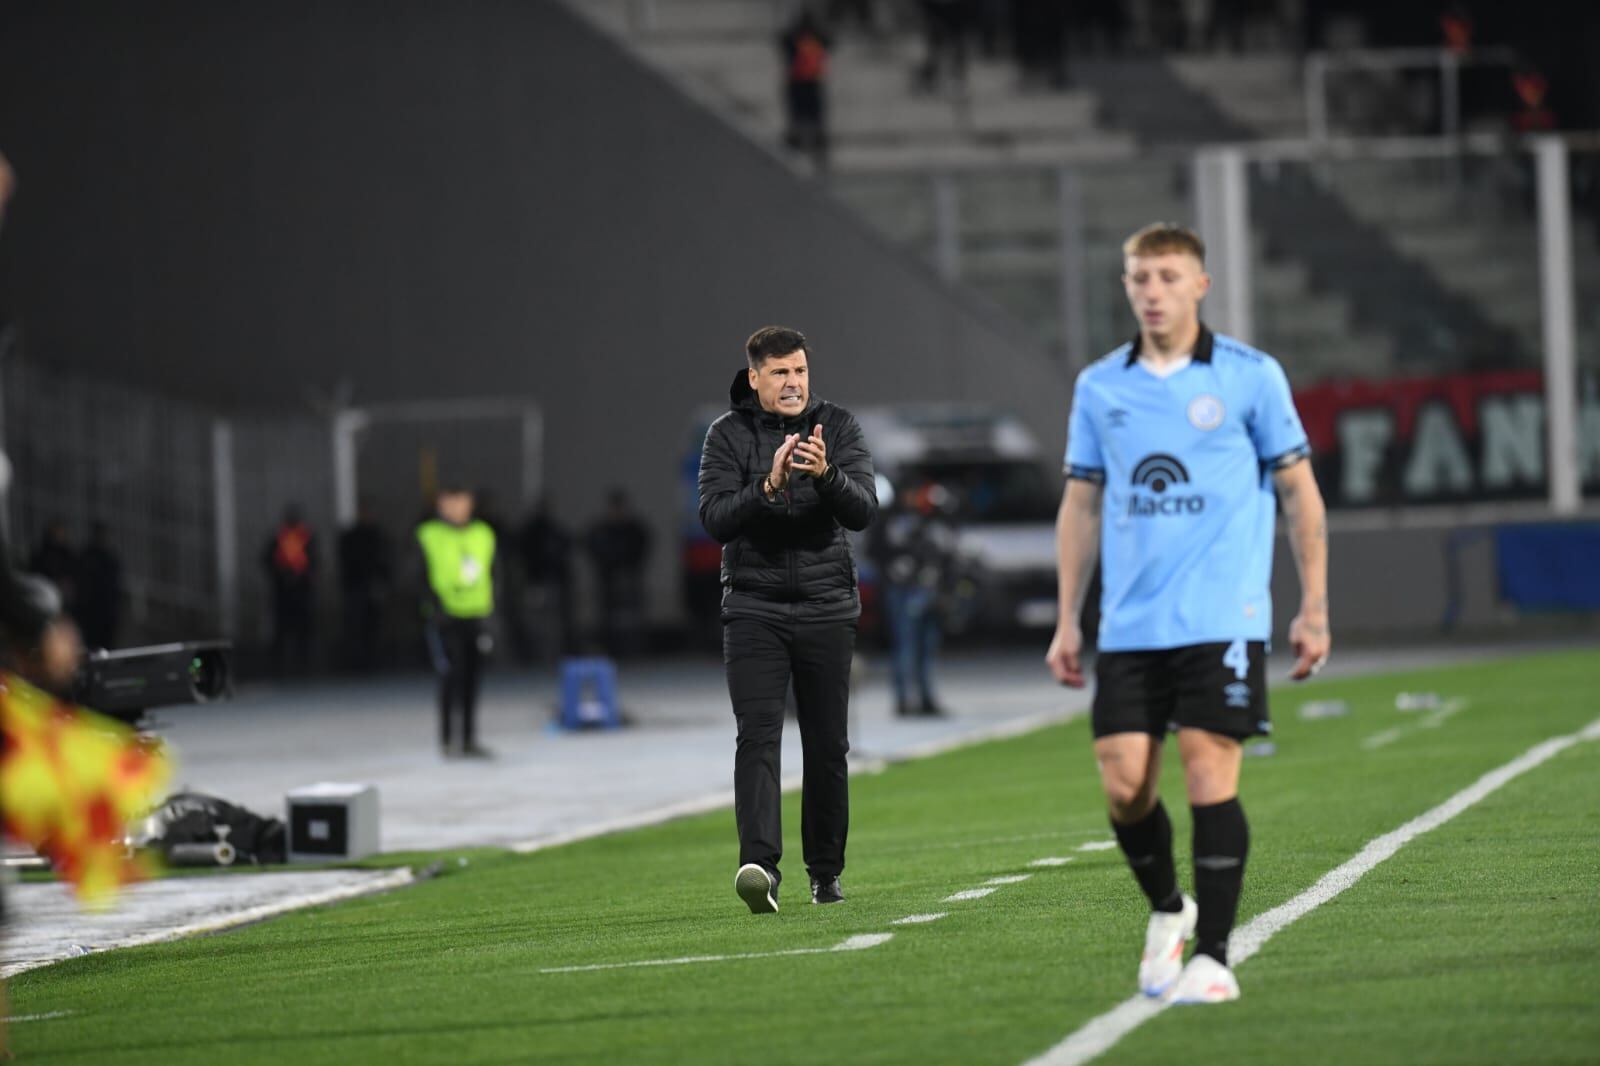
[[1045, 224, 1330, 1004]]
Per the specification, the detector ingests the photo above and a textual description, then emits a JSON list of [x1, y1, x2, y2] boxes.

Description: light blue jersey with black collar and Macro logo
[[1066, 327, 1310, 651]]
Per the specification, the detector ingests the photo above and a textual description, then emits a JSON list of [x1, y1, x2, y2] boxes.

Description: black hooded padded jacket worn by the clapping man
[[699, 370, 878, 623]]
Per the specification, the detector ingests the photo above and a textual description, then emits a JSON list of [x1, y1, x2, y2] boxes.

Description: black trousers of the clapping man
[[722, 618, 856, 880]]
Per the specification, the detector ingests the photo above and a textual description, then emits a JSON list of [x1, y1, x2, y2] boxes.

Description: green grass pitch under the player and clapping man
[[10, 653, 1600, 1066]]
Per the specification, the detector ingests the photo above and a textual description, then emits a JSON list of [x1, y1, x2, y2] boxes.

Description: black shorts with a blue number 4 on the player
[[1091, 640, 1272, 739]]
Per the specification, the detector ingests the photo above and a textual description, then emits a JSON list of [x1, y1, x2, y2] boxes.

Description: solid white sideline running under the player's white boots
[[1027, 719, 1600, 1066]]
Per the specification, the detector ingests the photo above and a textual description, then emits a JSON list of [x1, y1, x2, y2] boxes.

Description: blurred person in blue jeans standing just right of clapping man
[[872, 485, 955, 715]]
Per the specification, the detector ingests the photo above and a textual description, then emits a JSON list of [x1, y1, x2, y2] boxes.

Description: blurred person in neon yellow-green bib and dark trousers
[[416, 487, 498, 759]]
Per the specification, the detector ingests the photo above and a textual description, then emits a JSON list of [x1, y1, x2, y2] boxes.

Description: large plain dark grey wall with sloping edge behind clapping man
[[0, 0, 1070, 630]]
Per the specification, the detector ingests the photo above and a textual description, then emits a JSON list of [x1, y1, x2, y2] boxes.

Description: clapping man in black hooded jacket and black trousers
[[699, 327, 878, 914]]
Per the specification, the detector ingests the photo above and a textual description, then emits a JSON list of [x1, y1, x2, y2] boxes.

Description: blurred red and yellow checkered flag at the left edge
[[0, 672, 171, 906]]
